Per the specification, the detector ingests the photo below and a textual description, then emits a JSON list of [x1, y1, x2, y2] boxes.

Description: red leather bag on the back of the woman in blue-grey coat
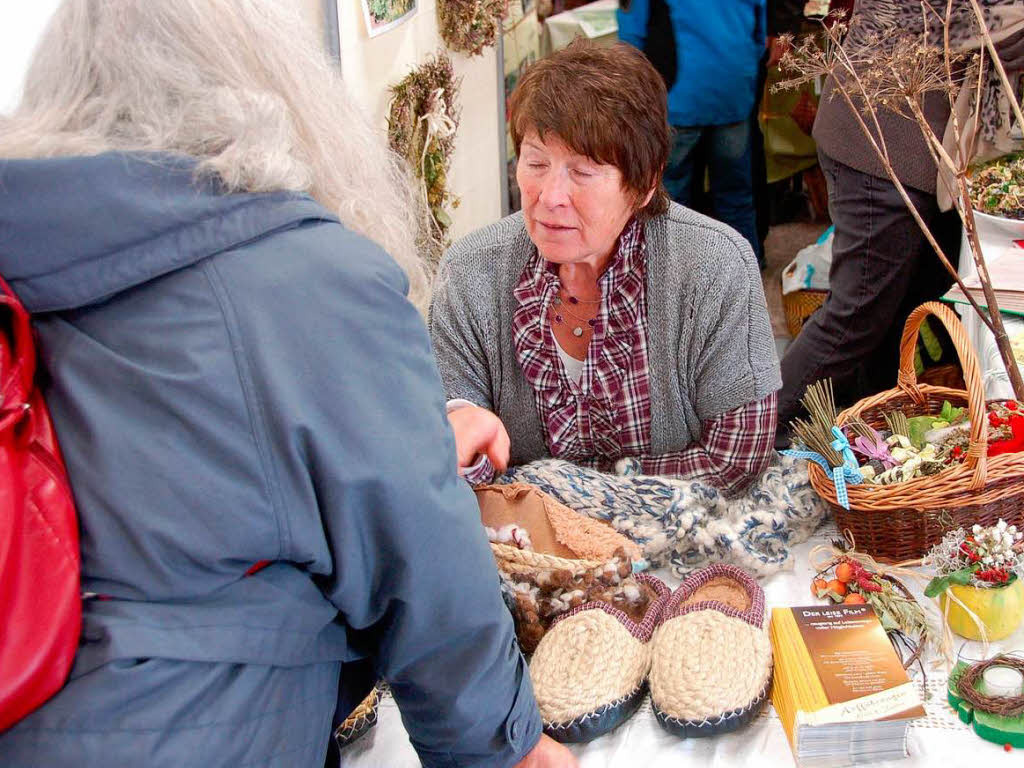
[[0, 279, 82, 731]]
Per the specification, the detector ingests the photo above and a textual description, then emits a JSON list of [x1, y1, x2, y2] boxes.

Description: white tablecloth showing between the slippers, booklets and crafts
[[341, 522, 1024, 768]]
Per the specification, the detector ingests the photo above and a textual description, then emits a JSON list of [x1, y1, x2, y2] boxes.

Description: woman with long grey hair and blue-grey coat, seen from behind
[[0, 0, 575, 768]]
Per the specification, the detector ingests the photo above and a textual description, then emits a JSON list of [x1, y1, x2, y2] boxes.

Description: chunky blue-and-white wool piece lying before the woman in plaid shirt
[[496, 455, 827, 578]]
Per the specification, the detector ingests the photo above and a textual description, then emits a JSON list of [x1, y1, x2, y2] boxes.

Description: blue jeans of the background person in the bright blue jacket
[[664, 121, 762, 261]]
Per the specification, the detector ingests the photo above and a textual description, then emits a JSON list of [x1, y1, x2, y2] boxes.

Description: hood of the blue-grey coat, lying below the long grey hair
[[0, 153, 337, 312]]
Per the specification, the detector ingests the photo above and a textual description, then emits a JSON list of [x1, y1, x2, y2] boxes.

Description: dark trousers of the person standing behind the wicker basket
[[778, 153, 961, 427]]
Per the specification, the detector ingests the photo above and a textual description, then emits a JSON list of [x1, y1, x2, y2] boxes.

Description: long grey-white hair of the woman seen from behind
[[0, 0, 429, 309]]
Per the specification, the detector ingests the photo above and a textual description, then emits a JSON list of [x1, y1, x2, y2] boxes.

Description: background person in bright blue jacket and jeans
[[618, 0, 766, 261]]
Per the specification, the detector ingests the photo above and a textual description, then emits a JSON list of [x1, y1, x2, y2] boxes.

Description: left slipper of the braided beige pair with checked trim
[[529, 573, 670, 742]]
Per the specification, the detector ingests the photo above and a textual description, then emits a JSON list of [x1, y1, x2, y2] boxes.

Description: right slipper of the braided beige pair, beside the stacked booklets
[[649, 564, 772, 738]]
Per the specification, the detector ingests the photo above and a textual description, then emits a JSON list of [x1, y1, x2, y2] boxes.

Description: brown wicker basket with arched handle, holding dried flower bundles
[[808, 302, 1024, 562]]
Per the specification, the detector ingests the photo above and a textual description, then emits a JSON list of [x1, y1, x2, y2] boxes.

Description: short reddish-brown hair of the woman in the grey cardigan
[[509, 38, 669, 220]]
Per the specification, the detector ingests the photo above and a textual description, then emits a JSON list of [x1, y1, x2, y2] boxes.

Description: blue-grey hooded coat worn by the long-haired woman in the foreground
[[0, 154, 541, 768]]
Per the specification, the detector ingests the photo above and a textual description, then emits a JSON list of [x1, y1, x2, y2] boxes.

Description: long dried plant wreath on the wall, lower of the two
[[387, 52, 461, 263]]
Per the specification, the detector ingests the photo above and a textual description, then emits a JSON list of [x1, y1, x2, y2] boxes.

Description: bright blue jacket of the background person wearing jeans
[[617, 0, 767, 127]]
